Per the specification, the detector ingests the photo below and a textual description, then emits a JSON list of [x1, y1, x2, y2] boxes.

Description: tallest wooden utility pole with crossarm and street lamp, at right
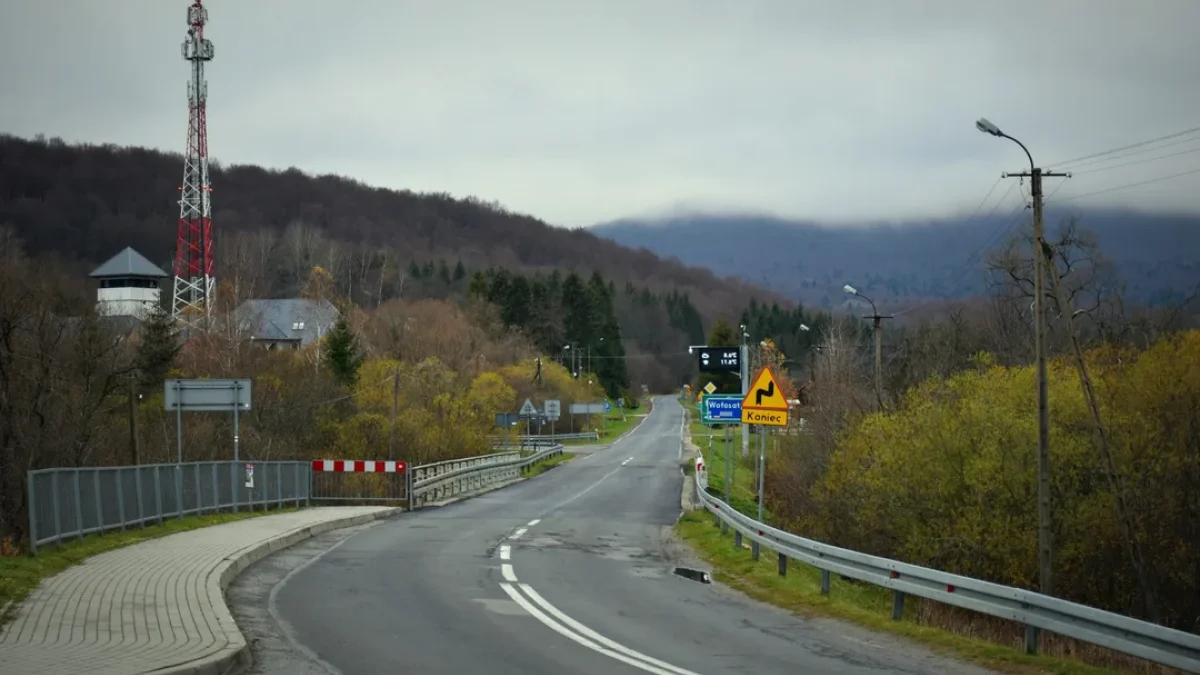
[[976, 118, 1070, 607]]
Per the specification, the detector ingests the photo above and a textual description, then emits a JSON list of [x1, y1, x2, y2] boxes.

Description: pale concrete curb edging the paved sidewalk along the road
[[155, 508, 404, 675]]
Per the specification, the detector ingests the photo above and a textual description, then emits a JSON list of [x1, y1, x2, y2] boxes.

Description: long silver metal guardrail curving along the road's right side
[[694, 473, 1200, 673]]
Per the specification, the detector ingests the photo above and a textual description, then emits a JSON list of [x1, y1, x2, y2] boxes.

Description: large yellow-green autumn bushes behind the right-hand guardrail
[[790, 330, 1200, 629]]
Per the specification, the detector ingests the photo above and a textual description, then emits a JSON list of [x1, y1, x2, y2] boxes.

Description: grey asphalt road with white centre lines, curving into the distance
[[230, 396, 988, 675]]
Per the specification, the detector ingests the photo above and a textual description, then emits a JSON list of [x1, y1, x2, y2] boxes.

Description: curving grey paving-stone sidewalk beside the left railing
[[0, 507, 397, 675]]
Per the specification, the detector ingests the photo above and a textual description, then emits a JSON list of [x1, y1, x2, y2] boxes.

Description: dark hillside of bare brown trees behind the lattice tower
[[0, 136, 782, 319]]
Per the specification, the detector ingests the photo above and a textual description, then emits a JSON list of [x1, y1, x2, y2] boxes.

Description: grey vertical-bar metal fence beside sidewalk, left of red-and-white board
[[26, 461, 312, 552]]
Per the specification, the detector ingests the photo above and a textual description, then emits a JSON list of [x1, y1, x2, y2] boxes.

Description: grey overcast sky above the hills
[[0, 0, 1200, 226]]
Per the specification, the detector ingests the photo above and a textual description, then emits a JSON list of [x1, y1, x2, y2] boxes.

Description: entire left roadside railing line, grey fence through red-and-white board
[[26, 444, 563, 552]]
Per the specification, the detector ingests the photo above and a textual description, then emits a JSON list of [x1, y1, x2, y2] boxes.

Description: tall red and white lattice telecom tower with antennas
[[172, 0, 216, 324]]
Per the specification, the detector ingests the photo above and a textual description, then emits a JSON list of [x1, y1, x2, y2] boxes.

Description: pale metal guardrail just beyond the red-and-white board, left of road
[[409, 444, 563, 509]]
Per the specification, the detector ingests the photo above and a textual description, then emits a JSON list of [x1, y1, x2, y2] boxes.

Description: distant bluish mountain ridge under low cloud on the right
[[592, 205, 1200, 309]]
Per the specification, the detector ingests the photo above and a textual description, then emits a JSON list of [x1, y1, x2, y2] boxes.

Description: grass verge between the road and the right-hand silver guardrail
[[676, 509, 1118, 675]]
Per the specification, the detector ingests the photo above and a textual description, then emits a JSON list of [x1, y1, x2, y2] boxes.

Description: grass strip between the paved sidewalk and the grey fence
[[0, 508, 296, 626]]
